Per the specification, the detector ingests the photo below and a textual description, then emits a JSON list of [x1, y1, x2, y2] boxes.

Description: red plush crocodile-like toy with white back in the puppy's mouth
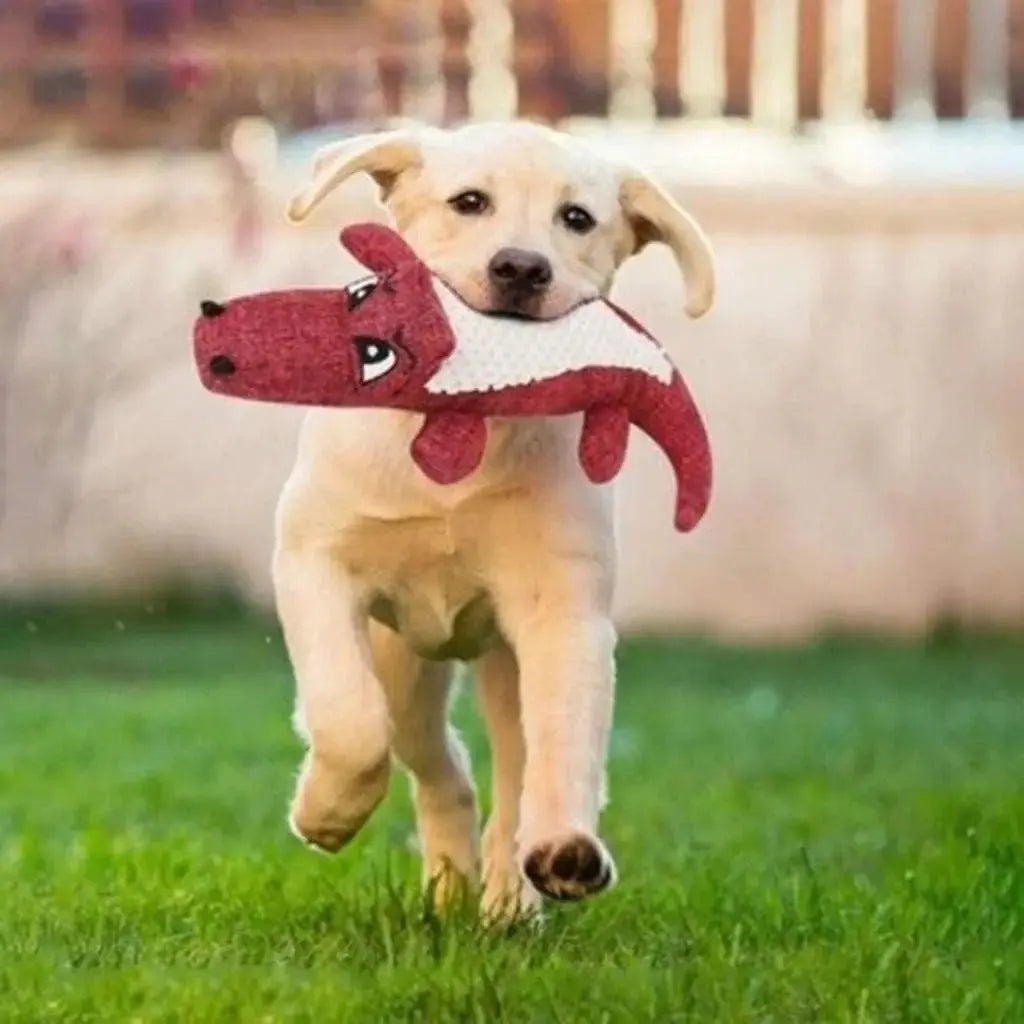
[[195, 224, 712, 530]]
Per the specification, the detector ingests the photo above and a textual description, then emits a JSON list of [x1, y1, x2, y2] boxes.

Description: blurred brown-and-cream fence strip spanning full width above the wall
[[0, 0, 1024, 144]]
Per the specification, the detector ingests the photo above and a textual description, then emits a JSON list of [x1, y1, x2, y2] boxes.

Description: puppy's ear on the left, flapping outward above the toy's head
[[286, 130, 422, 224]]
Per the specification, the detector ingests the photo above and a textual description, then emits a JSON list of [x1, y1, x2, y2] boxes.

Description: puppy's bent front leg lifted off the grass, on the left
[[273, 540, 391, 852]]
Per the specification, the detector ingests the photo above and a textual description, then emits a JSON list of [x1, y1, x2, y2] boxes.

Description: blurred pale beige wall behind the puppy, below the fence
[[0, 148, 1024, 636]]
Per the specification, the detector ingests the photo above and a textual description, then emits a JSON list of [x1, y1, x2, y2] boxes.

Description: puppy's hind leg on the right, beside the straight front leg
[[476, 647, 539, 922]]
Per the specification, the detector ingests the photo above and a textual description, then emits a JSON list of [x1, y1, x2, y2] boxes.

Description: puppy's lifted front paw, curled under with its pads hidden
[[288, 754, 391, 853]]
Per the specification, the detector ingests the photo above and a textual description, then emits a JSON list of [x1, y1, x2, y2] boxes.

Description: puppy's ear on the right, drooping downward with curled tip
[[618, 171, 715, 318]]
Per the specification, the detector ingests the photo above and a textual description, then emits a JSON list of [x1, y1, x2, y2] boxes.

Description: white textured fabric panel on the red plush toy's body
[[426, 281, 673, 394]]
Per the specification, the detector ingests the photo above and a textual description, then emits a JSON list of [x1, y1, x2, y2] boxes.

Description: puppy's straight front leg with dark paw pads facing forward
[[487, 557, 615, 900]]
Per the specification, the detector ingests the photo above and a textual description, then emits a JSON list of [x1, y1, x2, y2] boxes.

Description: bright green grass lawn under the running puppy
[[0, 606, 1024, 1024]]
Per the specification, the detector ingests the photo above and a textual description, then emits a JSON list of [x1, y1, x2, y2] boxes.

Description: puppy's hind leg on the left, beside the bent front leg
[[370, 622, 479, 905]]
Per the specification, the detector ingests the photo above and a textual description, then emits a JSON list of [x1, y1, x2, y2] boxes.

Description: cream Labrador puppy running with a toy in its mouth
[[273, 123, 714, 916]]
